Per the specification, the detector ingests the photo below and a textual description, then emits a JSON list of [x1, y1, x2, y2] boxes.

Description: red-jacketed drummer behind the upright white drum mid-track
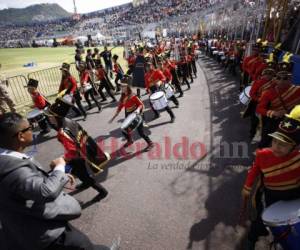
[[145, 62, 175, 123]]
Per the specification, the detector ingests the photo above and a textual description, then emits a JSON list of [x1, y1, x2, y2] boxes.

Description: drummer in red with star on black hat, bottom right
[[242, 106, 300, 250]]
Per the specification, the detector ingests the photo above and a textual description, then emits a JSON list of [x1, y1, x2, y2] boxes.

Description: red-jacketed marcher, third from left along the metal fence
[[79, 62, 102, 112]]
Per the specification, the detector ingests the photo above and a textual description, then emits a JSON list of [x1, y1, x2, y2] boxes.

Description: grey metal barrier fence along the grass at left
[[7, 63, 79, 108]]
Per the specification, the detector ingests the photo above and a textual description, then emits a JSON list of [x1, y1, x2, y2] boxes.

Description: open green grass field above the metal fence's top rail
[[0, 47, 127, 77]]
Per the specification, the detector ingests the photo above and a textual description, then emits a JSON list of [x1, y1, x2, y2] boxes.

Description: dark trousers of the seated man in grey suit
[[45, 223, 96, 250]]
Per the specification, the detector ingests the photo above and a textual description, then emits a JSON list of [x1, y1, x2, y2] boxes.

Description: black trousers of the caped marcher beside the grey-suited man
[[68, 158, 107, 194]]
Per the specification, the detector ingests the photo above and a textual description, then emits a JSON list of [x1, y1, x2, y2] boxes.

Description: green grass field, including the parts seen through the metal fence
[[0, 47, 127, 113]]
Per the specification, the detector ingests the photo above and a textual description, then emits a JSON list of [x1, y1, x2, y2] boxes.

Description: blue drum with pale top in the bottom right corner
[[262, 199, 300, 250]]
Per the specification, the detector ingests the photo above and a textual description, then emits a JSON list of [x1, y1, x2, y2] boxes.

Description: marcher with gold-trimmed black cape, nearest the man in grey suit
[[46, 101, 110, 201]]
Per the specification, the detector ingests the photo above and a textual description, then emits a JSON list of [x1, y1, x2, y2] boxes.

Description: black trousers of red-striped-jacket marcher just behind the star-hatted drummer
[[258, 116, 282, 148]]
